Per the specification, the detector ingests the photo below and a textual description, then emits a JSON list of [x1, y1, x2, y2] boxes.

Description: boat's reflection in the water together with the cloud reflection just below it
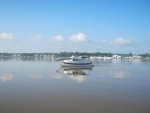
[[59, 67, 93, 83]]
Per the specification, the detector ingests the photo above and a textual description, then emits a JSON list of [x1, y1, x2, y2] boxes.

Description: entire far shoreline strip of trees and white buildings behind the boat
[[0, 52, 150, 60]]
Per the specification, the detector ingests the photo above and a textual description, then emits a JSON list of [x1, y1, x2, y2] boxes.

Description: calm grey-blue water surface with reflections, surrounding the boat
[[0, 59, 150, 113]]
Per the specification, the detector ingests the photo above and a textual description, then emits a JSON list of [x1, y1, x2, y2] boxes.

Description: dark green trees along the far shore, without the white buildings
[[0, 52, 150, 58]]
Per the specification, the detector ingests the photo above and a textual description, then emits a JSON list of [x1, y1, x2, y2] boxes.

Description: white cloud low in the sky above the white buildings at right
[[112, 37, 132, 45]]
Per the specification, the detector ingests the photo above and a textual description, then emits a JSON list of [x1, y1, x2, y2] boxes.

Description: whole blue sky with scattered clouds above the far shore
[[0, 0, 150, 54]]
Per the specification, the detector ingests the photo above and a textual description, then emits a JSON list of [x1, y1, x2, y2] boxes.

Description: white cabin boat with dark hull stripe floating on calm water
[[60, 56, 94, 67]]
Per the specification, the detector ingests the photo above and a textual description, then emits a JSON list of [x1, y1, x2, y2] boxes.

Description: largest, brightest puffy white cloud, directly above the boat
[[69, 33, 89, 42]]
